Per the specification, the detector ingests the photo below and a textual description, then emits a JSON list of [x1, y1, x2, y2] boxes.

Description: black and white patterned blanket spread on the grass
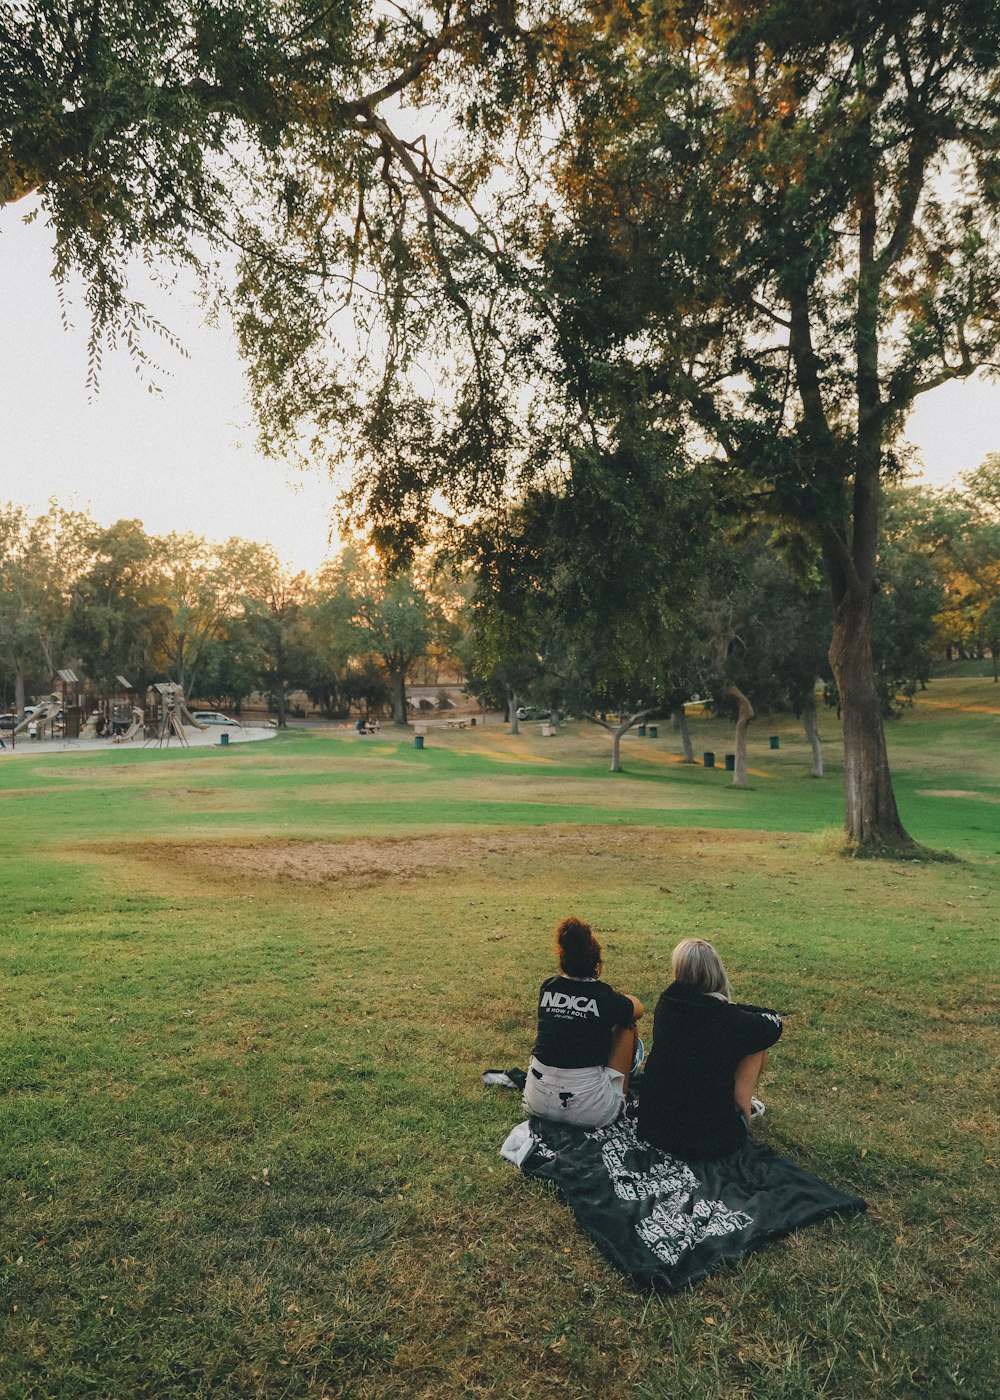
[[500, 1117, 866, 1292]]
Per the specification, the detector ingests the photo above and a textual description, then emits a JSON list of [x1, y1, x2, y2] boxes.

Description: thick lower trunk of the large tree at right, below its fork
[[829, 592, 913, 853]]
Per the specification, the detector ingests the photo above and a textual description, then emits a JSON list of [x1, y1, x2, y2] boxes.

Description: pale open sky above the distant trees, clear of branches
[[0, 200, 1000, 570]]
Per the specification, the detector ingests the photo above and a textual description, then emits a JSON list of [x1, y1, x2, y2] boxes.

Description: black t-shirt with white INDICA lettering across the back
[[531, 977, 636, 1070]]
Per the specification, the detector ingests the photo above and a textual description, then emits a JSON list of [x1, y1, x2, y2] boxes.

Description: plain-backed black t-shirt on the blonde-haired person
[[639, 981, 782, 1158]]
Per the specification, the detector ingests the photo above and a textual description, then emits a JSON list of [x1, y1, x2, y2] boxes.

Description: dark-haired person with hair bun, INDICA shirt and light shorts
[[524, 918, 643, 1127]]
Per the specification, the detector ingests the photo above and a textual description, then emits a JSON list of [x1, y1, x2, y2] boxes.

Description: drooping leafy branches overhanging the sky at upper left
[[0, 0, 528, 487]]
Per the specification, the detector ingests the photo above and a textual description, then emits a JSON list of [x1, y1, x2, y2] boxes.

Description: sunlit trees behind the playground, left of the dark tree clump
[[0, 515, 462, 725]]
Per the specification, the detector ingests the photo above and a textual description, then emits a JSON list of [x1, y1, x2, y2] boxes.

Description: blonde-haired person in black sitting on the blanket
[[639, 938, 782, 1158]]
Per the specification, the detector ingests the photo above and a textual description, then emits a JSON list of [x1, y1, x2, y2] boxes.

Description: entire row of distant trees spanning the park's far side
[[0, 451, 1000, 750]]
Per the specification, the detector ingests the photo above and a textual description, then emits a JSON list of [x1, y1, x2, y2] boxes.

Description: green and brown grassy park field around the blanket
[[0, 678, 1000, 1400]]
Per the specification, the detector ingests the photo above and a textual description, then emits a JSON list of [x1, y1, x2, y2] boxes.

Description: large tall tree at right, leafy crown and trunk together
[[515, 0, 1000, 848]]
